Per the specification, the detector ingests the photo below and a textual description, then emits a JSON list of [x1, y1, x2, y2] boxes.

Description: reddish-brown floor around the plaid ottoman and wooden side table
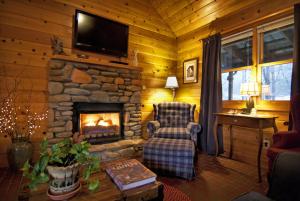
[[0, 153, 267, 201]]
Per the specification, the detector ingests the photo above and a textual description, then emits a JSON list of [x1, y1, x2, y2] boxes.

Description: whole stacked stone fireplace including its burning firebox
[[47, 59, 142, 161]]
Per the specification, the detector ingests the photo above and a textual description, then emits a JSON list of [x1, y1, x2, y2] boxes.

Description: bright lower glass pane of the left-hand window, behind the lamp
[[222, 69, 251, 100]]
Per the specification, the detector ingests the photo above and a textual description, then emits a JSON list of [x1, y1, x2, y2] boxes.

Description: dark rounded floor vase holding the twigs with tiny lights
[[7, 141, 33, 170]]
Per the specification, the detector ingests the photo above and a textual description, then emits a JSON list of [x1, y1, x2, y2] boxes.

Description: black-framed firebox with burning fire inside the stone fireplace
[[73, 103, 123, 144]]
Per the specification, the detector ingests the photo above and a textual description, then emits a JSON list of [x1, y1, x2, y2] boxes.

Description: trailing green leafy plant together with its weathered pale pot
[[23, 138, 99, 200]]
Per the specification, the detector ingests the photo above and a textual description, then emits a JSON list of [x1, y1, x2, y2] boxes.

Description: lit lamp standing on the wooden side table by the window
[[240, 82, 259, 114]]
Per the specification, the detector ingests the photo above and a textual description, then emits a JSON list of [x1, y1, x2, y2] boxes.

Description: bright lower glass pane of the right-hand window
[[261, 63, 293, 100]]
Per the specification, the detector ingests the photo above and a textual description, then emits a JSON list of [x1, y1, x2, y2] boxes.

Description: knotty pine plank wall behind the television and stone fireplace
[[0, 0, 177, 166]]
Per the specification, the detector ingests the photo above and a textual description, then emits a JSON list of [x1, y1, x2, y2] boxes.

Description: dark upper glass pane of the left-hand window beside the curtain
[[221, 37, 252, 70]]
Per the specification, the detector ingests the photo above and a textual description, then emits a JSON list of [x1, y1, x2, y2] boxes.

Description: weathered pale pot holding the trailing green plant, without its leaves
[[47, 163, 80, 195]]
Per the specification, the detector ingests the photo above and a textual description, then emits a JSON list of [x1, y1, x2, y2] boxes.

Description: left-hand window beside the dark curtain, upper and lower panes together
[[221, 31, 253, 100]]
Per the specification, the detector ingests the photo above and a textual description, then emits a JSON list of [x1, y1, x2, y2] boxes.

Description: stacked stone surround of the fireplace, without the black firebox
[[47, 59, 142, 143]]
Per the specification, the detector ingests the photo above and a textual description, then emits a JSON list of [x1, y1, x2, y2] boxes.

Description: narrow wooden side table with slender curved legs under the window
[[214, 113, 278, 182]]
